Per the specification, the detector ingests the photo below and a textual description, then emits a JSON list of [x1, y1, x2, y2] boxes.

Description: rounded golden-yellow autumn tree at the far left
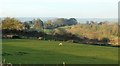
[[2, 17, 23, 30]]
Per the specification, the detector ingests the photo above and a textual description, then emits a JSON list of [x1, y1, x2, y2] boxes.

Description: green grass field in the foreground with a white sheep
[[2, 39, 118, 64]]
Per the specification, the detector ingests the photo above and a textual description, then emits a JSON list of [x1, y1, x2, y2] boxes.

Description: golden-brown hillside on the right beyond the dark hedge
[[62, 23, 120, 45]]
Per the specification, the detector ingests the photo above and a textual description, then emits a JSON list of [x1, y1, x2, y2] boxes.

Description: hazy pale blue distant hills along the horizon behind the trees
[[0, 17, 118, 23]]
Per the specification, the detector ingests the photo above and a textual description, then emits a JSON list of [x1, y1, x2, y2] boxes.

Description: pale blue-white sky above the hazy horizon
[[0, 0, 119, 18]]
